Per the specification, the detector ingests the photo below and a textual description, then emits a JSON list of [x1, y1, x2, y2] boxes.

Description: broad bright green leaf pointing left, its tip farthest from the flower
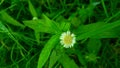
[[23, 19, 55, 33]]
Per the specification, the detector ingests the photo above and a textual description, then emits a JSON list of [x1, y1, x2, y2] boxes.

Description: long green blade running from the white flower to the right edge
[[77, 20, 120, 40]]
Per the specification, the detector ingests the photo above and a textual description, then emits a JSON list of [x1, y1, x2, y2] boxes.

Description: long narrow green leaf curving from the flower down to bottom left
[[37, 35, 59, 68]]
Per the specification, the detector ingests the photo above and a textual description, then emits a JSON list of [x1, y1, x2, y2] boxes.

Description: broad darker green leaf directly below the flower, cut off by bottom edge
[[59, 54, 79, 68]]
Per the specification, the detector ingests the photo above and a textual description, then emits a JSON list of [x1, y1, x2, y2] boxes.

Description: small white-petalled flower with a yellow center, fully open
[[60, 31, 76, 48]]
